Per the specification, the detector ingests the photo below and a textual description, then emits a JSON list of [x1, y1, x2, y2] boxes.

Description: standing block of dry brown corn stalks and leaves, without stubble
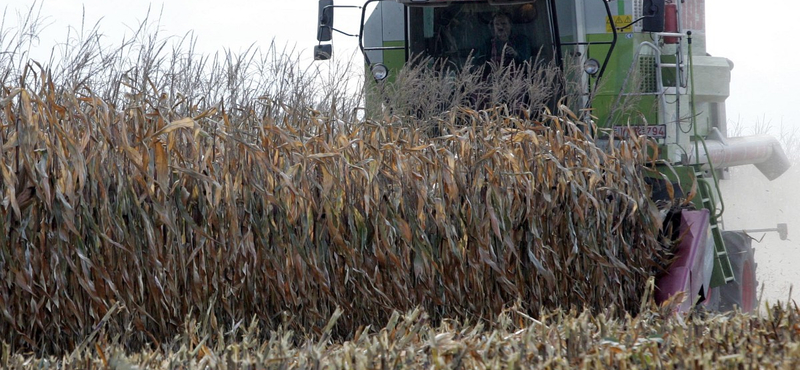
[[0, 66, 664, 353]]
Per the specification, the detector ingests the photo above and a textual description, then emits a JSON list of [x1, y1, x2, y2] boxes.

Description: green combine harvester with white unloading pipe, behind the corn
[[315, 0, 789, 311]]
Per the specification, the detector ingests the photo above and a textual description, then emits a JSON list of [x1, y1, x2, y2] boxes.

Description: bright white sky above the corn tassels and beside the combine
[[5, 0, 800, 130]]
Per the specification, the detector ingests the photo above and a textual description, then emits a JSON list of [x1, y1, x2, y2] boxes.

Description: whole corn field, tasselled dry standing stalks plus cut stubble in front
[[0, 7, 798, 369]]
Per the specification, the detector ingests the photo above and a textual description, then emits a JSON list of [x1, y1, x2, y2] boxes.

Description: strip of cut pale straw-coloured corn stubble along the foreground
[[0, 306, 800, 369]]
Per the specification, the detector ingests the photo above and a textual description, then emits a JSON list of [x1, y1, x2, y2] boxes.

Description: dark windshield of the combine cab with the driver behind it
[[409, 1, 553, 68]]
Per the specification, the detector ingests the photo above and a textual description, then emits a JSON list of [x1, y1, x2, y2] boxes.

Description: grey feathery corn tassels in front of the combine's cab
[[370, 52, 563, 124]]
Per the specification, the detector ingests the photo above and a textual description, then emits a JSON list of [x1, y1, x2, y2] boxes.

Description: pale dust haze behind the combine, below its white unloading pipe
[[720, 164, 800, 306]]
